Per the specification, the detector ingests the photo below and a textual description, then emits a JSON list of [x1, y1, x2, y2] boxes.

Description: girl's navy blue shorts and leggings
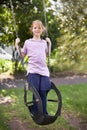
[[28, 73, 51, 114]]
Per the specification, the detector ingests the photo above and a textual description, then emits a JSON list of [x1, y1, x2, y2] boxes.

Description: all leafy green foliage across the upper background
[[0, 0, 87, 71]]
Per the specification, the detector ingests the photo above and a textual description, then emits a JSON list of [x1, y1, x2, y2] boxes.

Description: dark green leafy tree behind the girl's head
[[0, 0, 59, 48]]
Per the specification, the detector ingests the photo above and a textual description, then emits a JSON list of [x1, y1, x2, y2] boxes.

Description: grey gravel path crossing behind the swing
[[0, 74, 87, 89]]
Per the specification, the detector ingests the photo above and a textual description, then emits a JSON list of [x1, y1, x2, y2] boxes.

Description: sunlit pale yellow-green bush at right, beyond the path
[[50, 29, 87, 72]]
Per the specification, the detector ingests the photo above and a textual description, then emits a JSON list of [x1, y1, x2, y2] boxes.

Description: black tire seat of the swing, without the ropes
[[24, 82, 62, 125]]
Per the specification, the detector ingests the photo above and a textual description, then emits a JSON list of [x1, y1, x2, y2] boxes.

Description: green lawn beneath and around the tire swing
[[0, 84, 87, 130]]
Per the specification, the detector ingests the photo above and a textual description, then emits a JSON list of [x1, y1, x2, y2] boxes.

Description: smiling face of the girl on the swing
[[32, 22, 43, 37]]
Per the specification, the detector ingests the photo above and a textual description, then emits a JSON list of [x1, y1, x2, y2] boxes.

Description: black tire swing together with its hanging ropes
[[10, 0, 62, 125]]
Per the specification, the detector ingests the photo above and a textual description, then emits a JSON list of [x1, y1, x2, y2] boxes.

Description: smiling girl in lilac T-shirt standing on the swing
[[15, 20, 51, 114]]
